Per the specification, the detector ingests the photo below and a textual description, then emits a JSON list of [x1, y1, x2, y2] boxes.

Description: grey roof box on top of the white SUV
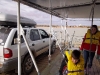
[[0, 13, 36, 27]]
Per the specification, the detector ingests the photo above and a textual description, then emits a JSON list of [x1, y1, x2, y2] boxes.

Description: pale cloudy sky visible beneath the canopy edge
[[0, 0, 100, 25]]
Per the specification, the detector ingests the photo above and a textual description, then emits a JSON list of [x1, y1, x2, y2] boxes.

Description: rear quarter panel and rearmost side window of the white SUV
[[7, 29, 27, 58]]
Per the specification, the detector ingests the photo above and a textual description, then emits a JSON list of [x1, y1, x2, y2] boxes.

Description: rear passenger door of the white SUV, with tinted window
[[30, 29, 43, 56]]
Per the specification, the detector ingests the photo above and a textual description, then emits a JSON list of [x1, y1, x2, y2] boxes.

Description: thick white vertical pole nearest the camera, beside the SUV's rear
[[17, 0, 21, 75]]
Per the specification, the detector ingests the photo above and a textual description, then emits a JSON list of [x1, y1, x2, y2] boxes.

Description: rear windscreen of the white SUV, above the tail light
[[0, 28, 11, 45]]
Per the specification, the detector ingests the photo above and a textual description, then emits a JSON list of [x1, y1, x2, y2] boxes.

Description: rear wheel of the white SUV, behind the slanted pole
[[22, 55, 34, 75]]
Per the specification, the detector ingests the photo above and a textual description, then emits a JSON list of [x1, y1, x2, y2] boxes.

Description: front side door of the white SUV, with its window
[[39, 29, 49, 51]]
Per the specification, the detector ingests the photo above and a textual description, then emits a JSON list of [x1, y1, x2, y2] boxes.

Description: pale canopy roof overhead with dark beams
[[14, 0, 100, 18]]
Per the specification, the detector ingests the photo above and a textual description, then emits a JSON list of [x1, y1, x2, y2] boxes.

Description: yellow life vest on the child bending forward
[[65, 50, 84, 75]]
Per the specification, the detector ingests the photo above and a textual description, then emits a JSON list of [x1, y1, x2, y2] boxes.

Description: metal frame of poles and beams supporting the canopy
[[8, 0, 97, 75]]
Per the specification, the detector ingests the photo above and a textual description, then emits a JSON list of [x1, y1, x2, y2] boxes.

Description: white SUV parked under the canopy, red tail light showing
[[0, 13, 56, 74]]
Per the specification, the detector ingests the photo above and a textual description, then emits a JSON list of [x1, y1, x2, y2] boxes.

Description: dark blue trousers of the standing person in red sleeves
[[83, 50, 95, 68]]
